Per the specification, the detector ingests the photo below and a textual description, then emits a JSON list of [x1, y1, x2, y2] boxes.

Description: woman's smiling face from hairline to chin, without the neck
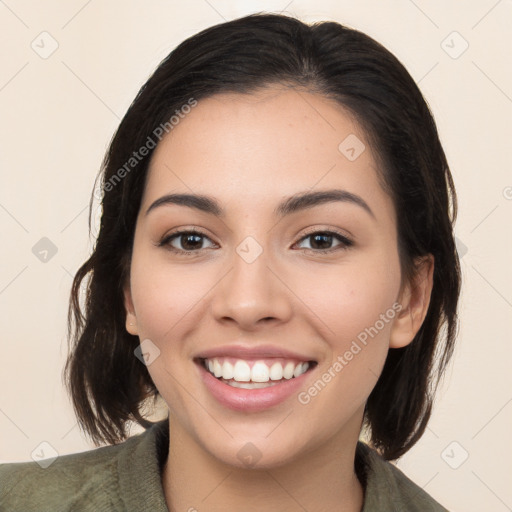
[[125, 88, 424, 467]]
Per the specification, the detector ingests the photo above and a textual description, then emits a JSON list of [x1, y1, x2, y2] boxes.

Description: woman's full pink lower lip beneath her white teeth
[[196, 363, 311, 412]]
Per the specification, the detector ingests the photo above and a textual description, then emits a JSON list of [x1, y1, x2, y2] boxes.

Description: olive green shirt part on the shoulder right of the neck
[[357, 442, 448, 512]]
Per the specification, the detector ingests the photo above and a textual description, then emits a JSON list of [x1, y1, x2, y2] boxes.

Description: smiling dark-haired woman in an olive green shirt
[[0, 14, 460, 512]]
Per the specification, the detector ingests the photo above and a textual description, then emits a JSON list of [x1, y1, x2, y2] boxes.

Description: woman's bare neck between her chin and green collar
[[163, 417, 364, 512]]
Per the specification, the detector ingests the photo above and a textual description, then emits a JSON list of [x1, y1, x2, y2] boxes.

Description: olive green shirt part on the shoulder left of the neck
[[0, 420, 169, 512]]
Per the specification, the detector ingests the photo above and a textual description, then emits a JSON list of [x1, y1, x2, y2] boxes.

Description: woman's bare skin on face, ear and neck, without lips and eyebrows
[[125, 87, 433, 512]]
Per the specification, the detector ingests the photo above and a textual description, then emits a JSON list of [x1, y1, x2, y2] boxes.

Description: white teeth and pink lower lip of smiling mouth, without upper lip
[[194, 356, 318, 412]]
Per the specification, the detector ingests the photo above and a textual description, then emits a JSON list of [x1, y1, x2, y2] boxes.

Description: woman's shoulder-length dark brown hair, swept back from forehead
[[64, 14, 460, 459]]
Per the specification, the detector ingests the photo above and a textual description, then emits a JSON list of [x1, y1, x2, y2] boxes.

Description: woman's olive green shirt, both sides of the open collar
[[0, 420, 447, 512]]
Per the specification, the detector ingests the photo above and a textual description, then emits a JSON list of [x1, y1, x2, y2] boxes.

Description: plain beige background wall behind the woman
[[0, 0, 512, 512]]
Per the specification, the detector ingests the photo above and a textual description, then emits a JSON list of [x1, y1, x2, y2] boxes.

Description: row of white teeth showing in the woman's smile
[[205, 358, 309, 382]]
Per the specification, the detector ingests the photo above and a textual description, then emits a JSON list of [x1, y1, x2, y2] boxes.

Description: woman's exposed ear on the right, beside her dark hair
[[389, 254, 434, 348]]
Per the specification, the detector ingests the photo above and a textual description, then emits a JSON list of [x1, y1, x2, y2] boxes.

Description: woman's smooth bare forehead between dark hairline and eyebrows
[[143, 87, 390, 218]]
